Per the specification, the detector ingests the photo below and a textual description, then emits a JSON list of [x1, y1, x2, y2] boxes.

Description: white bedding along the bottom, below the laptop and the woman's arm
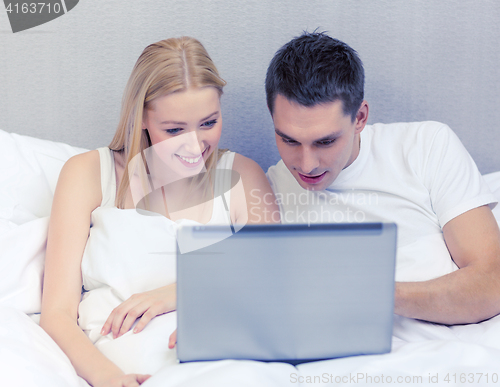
[[0, 306, 500, 387]]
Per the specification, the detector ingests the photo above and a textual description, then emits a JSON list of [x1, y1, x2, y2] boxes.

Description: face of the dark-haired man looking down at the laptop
[[273, 94, 368, 191]]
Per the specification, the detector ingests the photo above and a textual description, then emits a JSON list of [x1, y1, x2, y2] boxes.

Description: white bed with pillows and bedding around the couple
[[0, 131, 500, 387]]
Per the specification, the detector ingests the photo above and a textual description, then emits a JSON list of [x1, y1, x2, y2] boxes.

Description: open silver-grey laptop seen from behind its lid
[[177, 223, 397, 364]]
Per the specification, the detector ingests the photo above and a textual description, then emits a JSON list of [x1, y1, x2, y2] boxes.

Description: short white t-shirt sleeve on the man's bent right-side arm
[[424, 123, 497, 227]]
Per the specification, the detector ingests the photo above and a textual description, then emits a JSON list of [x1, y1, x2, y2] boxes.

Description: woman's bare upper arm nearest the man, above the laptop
[[231, 154, 280, 225]]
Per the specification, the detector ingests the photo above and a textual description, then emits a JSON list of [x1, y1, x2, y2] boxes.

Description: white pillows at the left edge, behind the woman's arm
[[0, 130, 85, 313]]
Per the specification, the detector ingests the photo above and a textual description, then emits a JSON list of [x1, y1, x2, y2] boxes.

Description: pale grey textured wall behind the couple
[[0, 0, 500, 173]]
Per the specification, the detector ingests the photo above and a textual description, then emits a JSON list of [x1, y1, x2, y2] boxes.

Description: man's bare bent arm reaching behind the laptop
[[394, 206, 500, 324]]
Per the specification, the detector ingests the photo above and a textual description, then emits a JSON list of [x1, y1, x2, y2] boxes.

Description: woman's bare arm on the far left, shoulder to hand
[[40, 151, 147, 386]]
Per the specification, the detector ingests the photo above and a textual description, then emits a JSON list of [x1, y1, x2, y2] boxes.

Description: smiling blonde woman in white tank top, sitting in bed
[[40, 37, 279, 387]]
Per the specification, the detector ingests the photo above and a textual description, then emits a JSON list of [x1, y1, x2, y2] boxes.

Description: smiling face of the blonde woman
[[143, 87, 222, 180]]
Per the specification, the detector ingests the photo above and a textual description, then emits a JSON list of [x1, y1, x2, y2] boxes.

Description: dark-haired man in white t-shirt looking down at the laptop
[[266, 33, 500, 324]]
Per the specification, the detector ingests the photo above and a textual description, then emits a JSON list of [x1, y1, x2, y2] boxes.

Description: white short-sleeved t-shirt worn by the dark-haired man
[[267, 121, 496, 281]]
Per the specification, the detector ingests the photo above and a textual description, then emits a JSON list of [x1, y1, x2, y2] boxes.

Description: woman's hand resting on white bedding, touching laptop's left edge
[[101, 284, 176, 339]]
